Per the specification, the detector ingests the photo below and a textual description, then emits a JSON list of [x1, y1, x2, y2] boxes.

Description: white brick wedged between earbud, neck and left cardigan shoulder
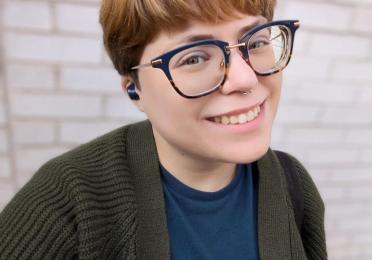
[[105, 95, 146, 120]]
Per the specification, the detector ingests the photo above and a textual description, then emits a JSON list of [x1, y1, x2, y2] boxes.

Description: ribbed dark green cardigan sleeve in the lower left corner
[[0, 160, 77, 260]]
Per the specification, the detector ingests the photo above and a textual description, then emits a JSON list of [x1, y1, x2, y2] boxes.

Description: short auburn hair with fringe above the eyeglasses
[[100, 0, 276, 75]]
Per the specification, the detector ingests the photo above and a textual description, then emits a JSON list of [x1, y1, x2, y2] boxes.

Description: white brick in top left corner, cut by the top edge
[[3, 1, 52, 30]]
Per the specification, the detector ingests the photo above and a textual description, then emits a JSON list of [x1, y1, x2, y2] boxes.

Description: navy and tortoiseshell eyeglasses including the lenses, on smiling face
[[131, 20, 300, 98]]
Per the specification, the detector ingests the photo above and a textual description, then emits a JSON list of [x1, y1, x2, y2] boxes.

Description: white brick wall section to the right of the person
[[274, 0, 372, 260]]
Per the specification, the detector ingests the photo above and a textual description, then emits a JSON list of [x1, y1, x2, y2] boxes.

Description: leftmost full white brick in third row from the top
[[7, 64, 56, 90]]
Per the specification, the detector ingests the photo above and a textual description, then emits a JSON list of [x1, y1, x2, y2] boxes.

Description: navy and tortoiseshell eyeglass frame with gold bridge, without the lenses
[[130, 20, 300, 99]]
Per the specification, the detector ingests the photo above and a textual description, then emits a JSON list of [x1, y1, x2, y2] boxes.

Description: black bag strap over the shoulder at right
[[275, 151, 304, 234]]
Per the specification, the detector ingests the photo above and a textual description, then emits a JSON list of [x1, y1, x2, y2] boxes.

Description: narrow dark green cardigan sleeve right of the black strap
[[292, 157, 327, 260]]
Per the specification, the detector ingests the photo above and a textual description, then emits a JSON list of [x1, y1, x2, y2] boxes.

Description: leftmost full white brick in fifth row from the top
[[13, 121, 56, 145]]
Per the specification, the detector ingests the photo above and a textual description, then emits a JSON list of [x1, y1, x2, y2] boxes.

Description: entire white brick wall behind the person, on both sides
[[0, 0, 372, 260]]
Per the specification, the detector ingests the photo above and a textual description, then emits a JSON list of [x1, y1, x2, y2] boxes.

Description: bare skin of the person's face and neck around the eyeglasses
[[122, 14, 282, 192]]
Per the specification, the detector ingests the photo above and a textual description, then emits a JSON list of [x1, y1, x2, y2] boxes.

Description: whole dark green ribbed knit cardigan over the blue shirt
[[0, 121, 327, 260]]
